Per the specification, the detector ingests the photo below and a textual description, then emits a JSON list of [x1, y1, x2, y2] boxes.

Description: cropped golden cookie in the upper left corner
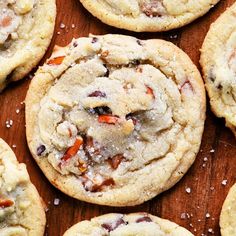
[[0, 0, 56, 91]]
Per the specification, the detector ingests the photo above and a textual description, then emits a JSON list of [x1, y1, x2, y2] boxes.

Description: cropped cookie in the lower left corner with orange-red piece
[[0, 139, 46, 236]]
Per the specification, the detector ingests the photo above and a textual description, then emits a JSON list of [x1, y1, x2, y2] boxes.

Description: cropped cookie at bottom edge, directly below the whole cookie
[[63, 213, 193, 236]]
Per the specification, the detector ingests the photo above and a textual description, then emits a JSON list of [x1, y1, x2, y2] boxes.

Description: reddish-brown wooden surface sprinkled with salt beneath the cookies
[[0, 0, 236, 236]]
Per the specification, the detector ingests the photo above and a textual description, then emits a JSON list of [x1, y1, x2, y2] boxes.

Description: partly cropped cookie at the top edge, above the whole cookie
[[80, 0, 219, 32]]
